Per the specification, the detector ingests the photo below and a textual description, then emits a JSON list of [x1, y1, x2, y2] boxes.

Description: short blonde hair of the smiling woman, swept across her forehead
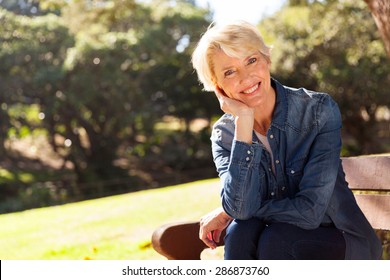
[[192, 21, 271, 91]]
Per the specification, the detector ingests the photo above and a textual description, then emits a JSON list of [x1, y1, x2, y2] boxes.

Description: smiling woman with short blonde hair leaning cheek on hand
[[192, 22, 382, 259]]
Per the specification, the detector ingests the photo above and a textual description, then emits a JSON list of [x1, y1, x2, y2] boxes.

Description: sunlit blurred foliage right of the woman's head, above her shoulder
[[261, 0, 390, 154]]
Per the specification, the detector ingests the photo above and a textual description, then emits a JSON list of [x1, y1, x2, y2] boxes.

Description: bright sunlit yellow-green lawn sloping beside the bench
[[0, 179, 219, 260]]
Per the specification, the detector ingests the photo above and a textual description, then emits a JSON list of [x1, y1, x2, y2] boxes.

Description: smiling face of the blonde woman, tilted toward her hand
[[212, 50, 272, 107]]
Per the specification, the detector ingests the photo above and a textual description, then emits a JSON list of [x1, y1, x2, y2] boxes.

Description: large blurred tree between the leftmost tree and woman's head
[[38, 1, 213, 182]]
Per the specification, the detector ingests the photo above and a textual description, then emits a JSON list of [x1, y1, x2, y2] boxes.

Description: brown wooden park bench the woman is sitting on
[[152, 155, 390, 260]]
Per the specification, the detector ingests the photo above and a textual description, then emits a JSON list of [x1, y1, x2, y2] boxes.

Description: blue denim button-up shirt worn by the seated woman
[[211, 79, 382, 259]]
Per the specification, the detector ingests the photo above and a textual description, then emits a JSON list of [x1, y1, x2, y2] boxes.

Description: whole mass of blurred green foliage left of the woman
[[0, 0, 218, 203]]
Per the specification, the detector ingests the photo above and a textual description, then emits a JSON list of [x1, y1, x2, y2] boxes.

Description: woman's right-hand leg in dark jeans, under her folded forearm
[[257, 223, 345, 260]]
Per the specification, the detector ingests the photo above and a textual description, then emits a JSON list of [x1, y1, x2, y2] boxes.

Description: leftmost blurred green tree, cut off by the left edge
[[0, 9, 74, 153]]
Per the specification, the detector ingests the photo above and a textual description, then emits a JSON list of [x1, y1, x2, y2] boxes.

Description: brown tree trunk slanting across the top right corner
[[364, 0, 390, 58]]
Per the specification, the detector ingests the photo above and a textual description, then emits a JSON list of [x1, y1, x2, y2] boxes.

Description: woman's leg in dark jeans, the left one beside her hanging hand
[[225, 218, 265, 260]]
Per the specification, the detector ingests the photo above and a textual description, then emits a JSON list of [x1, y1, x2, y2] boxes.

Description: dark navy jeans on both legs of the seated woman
[[225, 218, 345, 260]]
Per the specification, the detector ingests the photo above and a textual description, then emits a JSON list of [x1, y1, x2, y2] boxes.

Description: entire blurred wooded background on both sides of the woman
[[0, 0, 390, 213]]
